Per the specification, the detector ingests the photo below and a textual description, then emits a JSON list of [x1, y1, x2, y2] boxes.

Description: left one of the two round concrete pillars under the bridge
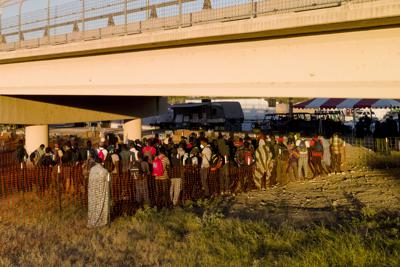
[[25, 125, 49, 155]]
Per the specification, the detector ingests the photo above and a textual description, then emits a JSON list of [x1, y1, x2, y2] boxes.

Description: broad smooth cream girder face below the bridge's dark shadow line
[[0, 25, 400, 99]]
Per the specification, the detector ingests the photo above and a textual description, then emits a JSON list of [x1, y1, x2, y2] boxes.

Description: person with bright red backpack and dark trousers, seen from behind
[[153, 147, 170, 209]]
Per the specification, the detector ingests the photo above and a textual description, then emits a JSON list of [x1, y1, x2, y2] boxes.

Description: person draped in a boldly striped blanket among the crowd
[[254, 136, 272, 190]]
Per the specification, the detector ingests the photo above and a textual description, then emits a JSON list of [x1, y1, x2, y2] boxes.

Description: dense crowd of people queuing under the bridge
[[16, 132, 345, 226]]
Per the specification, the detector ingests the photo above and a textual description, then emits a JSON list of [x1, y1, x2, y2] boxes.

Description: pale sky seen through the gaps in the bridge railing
[[1, 0, 251, 42]]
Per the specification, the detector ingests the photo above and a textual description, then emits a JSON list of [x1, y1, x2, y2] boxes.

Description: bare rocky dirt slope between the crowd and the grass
[[217, 167, 400, 226]]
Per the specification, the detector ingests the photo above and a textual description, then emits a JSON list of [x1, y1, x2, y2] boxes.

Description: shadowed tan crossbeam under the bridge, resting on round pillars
[[0, 96, 167, 125]]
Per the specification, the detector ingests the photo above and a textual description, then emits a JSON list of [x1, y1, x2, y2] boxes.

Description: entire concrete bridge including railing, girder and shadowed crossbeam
[[0, 0, 400, 153]]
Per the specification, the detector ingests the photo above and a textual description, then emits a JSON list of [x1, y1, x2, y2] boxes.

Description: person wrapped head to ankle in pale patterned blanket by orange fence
[[87, 158, 111, 228]]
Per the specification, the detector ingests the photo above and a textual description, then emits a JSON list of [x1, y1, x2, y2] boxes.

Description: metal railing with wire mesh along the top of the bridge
[[0, 0, 377, 51]]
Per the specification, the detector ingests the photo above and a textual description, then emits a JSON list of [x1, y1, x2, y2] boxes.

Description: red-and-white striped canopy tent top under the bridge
[[293, 98, 400, 109]]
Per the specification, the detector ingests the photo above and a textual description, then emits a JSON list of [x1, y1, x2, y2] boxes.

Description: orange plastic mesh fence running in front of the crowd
[[0, 160, 254, 221]]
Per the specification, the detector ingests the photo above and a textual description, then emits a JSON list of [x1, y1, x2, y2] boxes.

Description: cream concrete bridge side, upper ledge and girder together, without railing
[[0, 0, 400, 98]]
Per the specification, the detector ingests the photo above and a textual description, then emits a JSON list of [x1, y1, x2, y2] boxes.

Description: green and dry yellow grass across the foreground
[[0, 195, 400, 266]]
